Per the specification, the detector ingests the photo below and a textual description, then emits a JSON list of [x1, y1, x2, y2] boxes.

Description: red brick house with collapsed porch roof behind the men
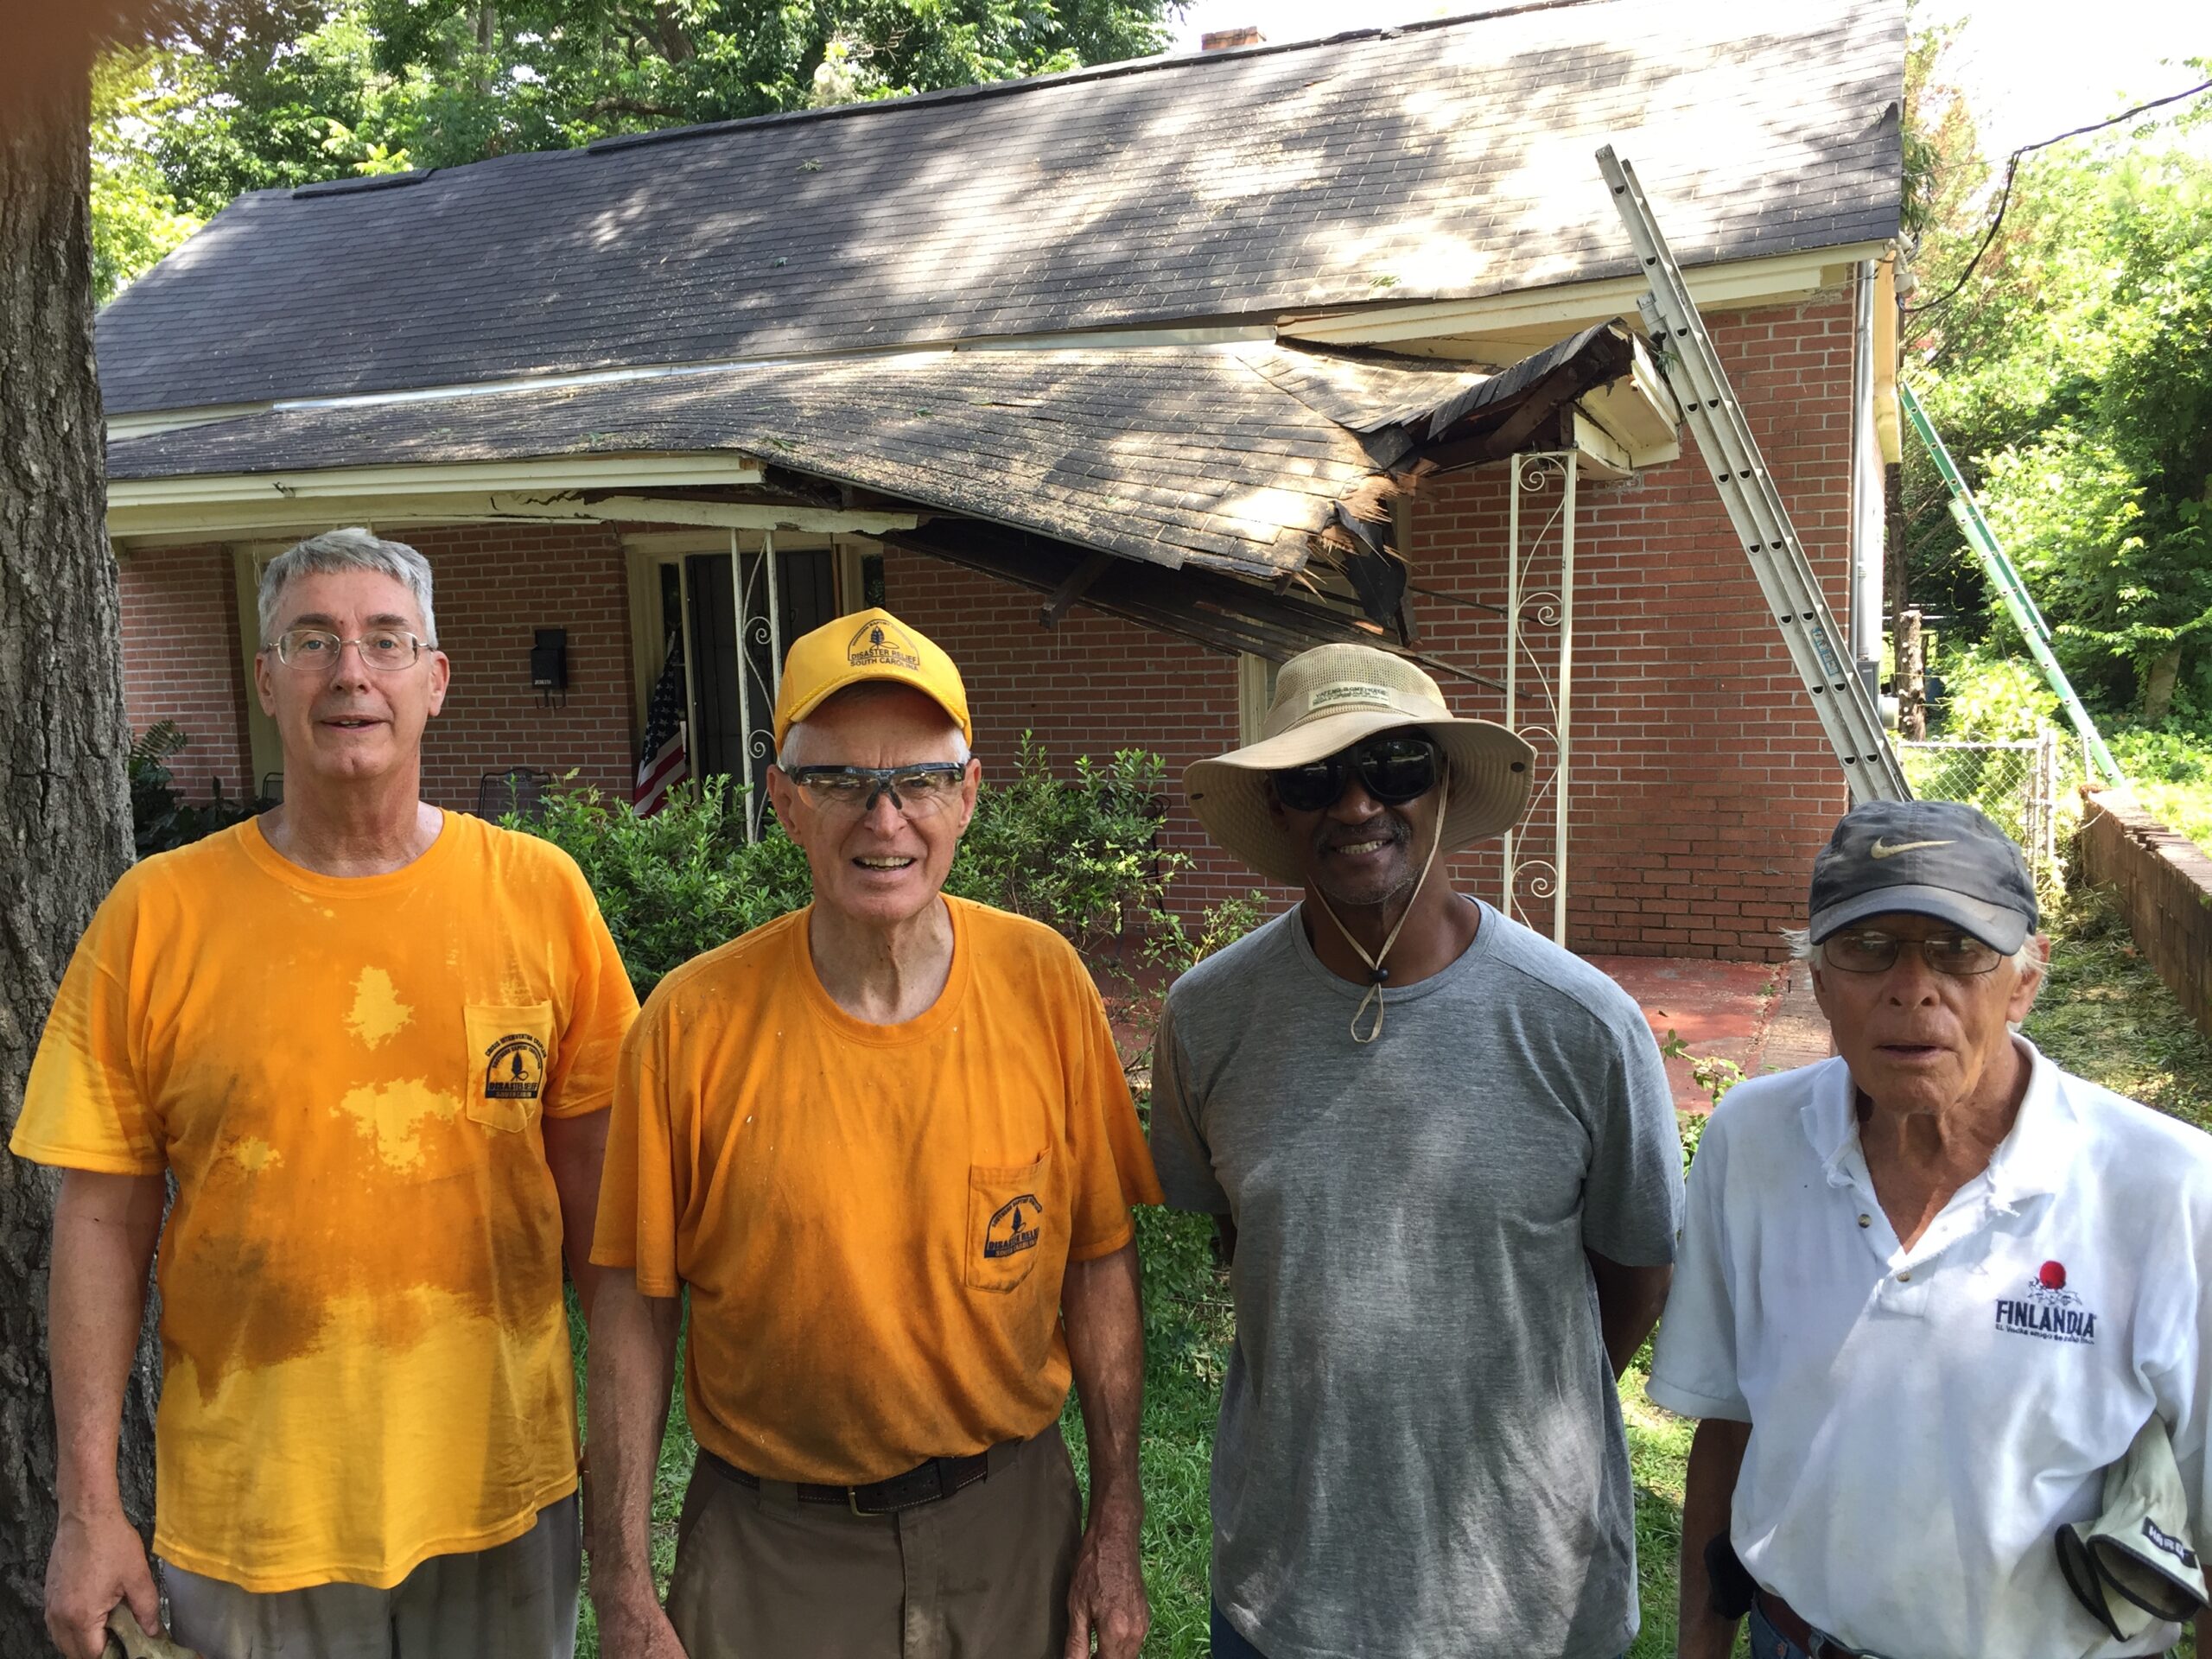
[[99, 0, 1904, 957]]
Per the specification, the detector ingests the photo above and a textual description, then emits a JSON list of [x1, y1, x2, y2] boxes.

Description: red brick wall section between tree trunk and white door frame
[[115, 546, 254, 801]]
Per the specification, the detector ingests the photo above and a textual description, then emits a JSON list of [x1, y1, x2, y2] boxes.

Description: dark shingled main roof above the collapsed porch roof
[[99, 0, 1904, 414]]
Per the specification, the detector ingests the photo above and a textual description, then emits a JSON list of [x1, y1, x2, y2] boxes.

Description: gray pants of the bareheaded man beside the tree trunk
[[159, 1496, 584, 1659]]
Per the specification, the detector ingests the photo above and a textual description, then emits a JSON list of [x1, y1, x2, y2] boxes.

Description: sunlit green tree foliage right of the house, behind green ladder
[[1904, 38, 2212, 716]]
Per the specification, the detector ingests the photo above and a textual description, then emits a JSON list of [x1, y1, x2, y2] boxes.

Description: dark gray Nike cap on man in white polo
[[1812, 801, 2039, 956]]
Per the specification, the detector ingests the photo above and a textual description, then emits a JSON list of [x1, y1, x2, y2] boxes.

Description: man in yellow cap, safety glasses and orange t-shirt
[[591, 611, 1159, 1659]]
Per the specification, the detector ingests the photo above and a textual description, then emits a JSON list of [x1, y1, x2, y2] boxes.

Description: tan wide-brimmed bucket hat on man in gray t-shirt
[[1184, 646, 1535, 887]]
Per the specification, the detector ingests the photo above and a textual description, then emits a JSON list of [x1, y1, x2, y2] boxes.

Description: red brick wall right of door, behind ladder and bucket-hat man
[[885, 296, 1852, 957]]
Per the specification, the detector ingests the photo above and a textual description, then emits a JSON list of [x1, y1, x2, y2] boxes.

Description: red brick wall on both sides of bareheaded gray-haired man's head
[[122, 524, 635, 810]]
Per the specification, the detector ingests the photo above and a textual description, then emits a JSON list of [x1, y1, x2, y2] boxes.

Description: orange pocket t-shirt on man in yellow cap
[[591, 898, 1159, 1484]]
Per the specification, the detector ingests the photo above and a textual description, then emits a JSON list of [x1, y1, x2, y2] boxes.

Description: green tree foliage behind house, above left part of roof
[[104, 0, 1181, 236]]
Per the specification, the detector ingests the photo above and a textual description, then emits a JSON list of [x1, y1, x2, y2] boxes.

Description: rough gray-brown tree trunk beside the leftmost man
[[0, 61, 159, 1656]]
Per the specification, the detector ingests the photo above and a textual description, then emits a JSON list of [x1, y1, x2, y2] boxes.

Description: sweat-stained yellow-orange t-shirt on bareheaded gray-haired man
[[11, 814, 637, 1591]]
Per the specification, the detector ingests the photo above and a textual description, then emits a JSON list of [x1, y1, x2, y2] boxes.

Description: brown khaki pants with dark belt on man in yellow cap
[[668, 1425, 1082, 1659]]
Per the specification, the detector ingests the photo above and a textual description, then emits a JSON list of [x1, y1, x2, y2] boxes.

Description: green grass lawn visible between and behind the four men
[[570, 875, 2212, 1659]]
